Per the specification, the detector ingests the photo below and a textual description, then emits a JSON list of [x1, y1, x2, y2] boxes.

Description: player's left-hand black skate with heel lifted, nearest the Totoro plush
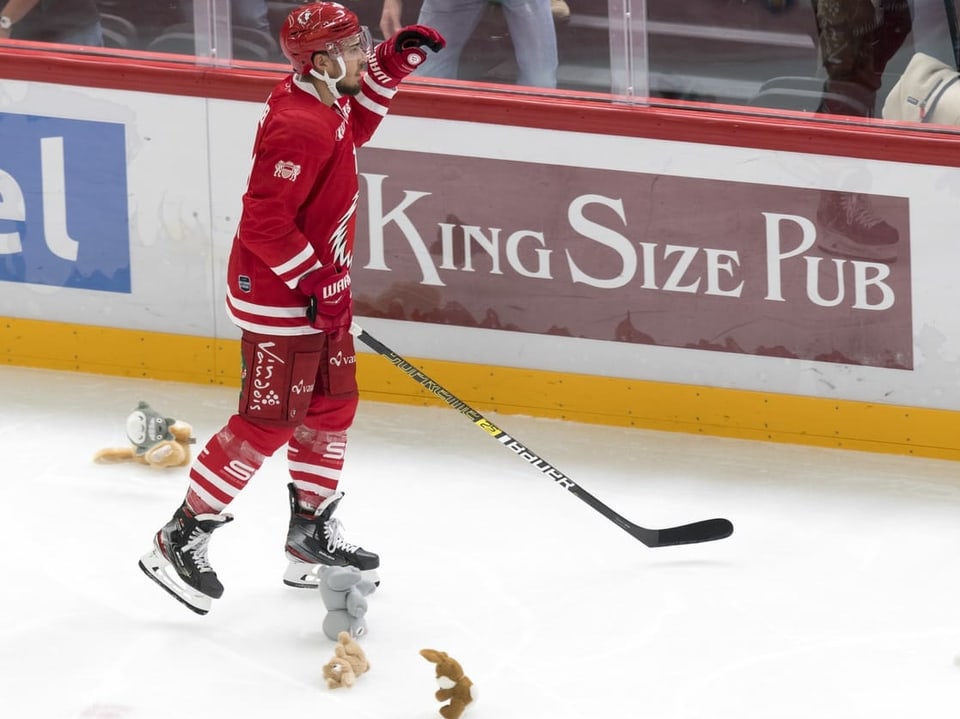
[[140, 507, 233, 614]]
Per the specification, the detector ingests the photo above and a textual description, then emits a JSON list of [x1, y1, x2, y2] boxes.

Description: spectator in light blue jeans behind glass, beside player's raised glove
[[380, 0, 556, 88]]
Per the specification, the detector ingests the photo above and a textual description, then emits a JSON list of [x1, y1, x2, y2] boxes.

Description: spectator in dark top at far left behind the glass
[[0, 0, 103, 47]]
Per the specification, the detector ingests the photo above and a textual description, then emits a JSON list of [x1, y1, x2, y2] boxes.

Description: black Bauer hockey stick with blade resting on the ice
[[350, 322, 733, 547]]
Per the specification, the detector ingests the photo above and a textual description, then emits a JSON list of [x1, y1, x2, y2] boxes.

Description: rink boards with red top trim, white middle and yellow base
[[0, 53, 960, 458]]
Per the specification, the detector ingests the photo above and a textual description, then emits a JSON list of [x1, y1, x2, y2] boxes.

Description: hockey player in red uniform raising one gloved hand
[[140, 2, 445, 614]]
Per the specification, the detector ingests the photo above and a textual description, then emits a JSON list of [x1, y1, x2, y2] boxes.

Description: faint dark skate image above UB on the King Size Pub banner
[[817, 192, 900, 263]]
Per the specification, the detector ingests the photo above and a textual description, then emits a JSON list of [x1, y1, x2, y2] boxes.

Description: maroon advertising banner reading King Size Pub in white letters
[[353, 148, 914, 370]]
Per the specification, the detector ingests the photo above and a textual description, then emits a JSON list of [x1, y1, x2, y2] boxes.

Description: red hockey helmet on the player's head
[[280, 2, 370, 75]]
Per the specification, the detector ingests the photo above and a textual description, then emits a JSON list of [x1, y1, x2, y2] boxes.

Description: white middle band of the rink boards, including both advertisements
[[0, 82, 960, 409]]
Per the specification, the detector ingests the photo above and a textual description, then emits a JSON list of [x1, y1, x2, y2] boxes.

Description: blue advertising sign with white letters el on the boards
[[0, 112, 130, 293]]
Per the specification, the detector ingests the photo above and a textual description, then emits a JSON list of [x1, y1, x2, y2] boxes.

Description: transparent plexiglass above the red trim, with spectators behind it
[[0, 0, 960, 125]]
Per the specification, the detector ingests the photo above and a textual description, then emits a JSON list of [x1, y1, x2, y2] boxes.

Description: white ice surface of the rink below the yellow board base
[[0, 366, 960, 719]]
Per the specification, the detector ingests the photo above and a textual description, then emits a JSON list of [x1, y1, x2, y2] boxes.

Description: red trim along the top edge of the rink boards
[[0, 42, 960, 167]]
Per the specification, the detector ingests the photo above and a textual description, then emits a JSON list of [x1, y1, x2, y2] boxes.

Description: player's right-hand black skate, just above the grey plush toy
[[283, 484, 380, 588]]
